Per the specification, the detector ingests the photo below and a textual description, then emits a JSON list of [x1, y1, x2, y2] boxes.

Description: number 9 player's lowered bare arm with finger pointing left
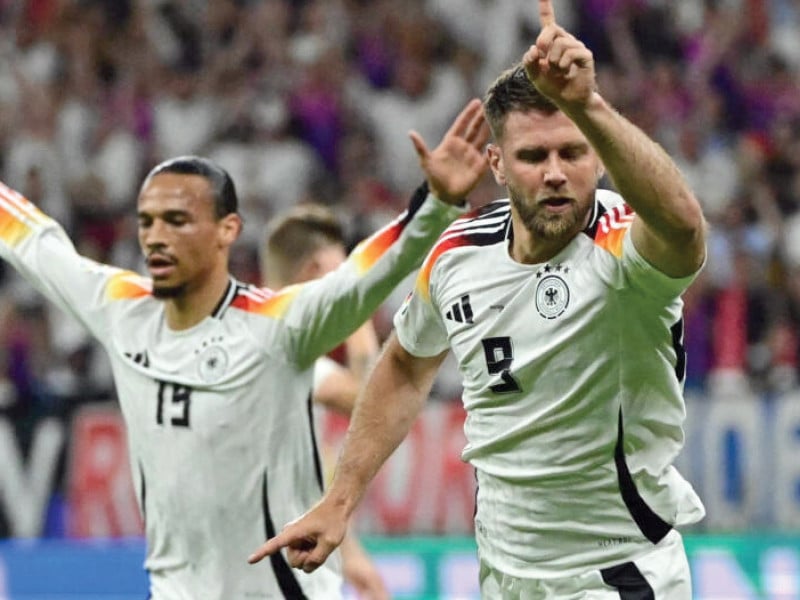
[[248, 335, 446, 573]]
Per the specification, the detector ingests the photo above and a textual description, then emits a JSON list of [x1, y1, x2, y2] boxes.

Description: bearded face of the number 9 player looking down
[[489, 111, 602, 242]]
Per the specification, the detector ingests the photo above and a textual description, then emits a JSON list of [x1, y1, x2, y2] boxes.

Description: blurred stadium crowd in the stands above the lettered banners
[[0, 0, 800, 452]]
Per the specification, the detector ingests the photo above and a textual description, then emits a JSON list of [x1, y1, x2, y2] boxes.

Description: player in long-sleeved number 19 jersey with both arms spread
[[0, 99, 488, 600]]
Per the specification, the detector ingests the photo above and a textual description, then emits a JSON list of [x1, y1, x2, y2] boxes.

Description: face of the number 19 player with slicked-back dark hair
[[138, 173, 223, 298]]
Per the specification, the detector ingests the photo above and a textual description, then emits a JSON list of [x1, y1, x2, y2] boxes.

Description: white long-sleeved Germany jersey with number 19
[[0, 186, 462, 600]]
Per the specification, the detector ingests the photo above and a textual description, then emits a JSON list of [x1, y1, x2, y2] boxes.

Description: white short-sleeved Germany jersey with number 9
[[395, 190, 704, 578]]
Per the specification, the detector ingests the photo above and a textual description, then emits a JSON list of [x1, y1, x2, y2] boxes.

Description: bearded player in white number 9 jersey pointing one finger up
[[250, 0, 705, 600]]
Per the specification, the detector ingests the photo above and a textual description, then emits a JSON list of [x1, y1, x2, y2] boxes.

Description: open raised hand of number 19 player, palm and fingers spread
[[409, 98, 489, 204]]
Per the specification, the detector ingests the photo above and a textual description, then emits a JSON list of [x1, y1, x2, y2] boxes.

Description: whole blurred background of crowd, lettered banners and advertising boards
[[0, 0, 800, 600]]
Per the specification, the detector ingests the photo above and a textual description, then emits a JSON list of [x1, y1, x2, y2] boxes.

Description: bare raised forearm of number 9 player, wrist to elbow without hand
[[563, 93, 703, 240]]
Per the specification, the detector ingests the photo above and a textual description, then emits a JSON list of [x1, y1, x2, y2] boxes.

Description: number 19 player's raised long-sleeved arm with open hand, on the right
[[280, 99, 489, 366]]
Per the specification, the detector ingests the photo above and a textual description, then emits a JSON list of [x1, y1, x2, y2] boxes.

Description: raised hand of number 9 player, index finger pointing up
[[522, 0, 596, 109]]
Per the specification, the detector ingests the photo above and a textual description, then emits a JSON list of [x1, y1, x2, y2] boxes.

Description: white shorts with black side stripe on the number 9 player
[[480, 529, 692, 600]]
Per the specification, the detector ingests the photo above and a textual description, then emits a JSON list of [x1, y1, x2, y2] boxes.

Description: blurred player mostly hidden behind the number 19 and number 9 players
[[260, 203, 389, 600]]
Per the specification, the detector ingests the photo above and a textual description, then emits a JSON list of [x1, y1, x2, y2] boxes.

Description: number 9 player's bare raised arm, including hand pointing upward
[[523, 0, 705, 277]]
